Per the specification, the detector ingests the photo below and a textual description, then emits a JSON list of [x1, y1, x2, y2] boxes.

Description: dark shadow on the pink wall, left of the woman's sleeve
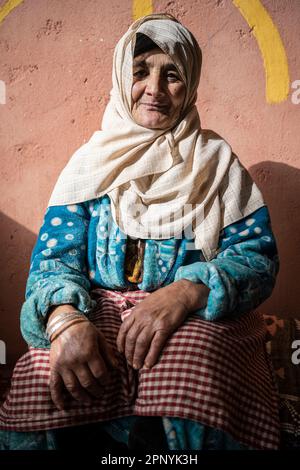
[[0, 213, 36, 377]]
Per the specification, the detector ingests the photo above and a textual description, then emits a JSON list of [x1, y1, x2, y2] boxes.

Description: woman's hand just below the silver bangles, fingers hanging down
[[50, 308, 117, 410]]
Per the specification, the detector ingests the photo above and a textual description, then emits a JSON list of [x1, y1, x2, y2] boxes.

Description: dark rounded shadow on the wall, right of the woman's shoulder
[[249, 161, 300, 319]]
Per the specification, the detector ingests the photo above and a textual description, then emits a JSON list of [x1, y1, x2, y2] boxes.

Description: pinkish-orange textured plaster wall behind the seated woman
[[0, 0, 300, 361]]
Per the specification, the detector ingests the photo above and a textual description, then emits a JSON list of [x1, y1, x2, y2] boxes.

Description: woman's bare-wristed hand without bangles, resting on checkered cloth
[[117, 279, 209, 369]]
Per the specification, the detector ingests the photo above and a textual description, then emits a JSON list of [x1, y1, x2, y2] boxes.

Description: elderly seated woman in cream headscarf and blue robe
[[0, 14, 279, 450]]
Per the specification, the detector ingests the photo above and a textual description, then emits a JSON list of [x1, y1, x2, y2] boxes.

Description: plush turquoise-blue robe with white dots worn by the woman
[[0, 196, 279, 450]]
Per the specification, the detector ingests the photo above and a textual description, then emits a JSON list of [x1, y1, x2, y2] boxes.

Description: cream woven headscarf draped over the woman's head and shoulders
[[49, 14, 264, 260]]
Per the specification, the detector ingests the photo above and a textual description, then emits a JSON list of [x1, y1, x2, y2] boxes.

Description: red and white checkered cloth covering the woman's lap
[[0, 289, 279, 449]]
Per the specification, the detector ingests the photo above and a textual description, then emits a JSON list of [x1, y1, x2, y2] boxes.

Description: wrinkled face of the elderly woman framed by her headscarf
[[131, 48, 186, 129]]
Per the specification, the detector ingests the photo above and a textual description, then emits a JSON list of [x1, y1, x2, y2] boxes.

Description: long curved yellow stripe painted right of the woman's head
[[233, 0, 290, 103]]
